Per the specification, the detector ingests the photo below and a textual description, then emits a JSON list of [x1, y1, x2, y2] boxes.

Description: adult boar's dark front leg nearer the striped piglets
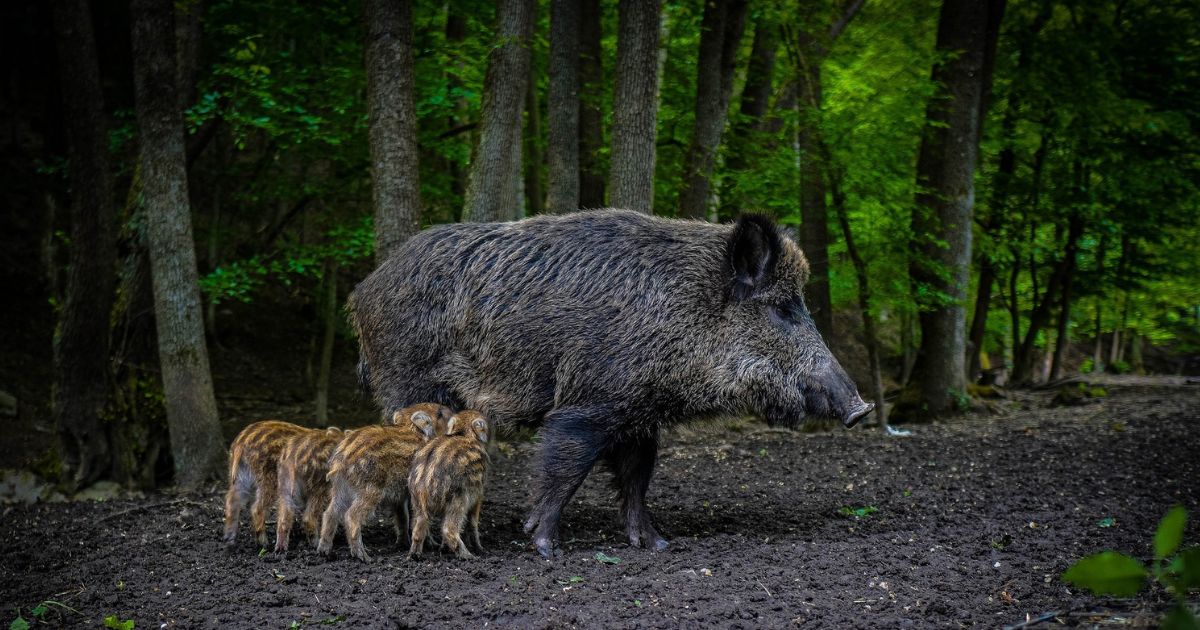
[[526, 407, 612, 558]]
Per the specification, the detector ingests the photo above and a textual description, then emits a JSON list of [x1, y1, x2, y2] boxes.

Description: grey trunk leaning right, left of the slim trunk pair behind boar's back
[[464, 0, 536, 221]]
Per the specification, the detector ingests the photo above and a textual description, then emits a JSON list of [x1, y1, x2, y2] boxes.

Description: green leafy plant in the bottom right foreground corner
[[1062, 505, 1200, 630]]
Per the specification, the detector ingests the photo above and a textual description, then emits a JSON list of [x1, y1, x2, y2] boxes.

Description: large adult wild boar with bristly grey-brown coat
[[349, 210, 872, 556]]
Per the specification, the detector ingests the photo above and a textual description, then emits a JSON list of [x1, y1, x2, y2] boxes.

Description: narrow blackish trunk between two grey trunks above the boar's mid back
[[580, 0, 605, 208]]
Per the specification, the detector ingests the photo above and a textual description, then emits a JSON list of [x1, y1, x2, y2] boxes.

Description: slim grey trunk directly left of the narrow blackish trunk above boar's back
[[546, 0, 580, 214]]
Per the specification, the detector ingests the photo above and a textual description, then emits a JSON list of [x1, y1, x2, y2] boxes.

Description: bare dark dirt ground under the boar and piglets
[[0, 379, 1200, 628]]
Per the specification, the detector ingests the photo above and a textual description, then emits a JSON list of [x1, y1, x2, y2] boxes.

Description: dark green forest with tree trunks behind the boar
[[0, 0, 1200, 487]]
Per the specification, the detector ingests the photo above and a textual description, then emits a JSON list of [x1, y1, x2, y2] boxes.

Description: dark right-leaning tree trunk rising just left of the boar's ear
[[679, 0, 746, 220]]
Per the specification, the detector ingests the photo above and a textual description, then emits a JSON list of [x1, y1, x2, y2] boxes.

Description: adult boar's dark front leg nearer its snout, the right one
[[605, 432, 667, 551]]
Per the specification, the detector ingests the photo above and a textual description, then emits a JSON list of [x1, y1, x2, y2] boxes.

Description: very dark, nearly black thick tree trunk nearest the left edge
[[52, 0, 116, 488]]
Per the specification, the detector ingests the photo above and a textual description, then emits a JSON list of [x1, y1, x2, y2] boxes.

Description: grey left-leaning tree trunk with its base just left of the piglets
[[131, 0, 224, 490]]
